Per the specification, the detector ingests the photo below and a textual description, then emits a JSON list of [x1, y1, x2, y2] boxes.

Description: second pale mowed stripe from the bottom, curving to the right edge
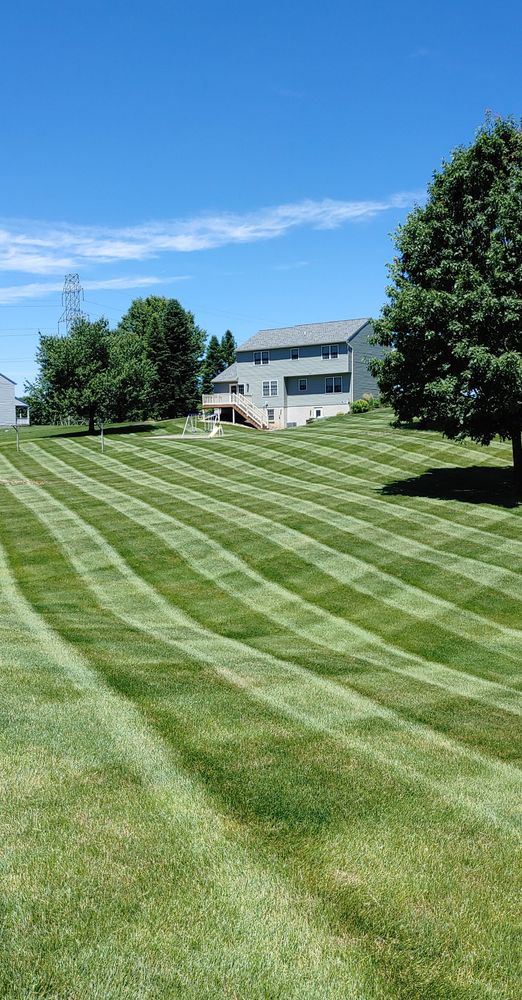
[[0, 450, 521, 837]]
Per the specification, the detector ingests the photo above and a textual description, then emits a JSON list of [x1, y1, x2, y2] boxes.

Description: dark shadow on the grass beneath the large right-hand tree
[[380, 465, 521, 508]]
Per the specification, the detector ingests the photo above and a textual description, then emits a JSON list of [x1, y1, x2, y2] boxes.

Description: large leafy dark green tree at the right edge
[[370, 119, 522, 490]]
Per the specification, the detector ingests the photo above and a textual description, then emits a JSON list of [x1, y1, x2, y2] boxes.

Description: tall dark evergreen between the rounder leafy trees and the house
[[151, 299, 206, 417]]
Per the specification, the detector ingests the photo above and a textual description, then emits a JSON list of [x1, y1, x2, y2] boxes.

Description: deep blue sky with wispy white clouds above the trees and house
[[0, 0, 522, 391]]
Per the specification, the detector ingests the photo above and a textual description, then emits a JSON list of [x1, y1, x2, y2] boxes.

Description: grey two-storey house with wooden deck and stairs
[[203, 319, 383, 428]]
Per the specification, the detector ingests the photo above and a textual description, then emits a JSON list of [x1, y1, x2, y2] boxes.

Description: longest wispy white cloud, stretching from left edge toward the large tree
[[0, 193, 423, 274]]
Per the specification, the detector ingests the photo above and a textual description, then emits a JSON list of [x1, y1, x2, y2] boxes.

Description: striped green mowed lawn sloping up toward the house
[[0, 410, 522, 1000]]
